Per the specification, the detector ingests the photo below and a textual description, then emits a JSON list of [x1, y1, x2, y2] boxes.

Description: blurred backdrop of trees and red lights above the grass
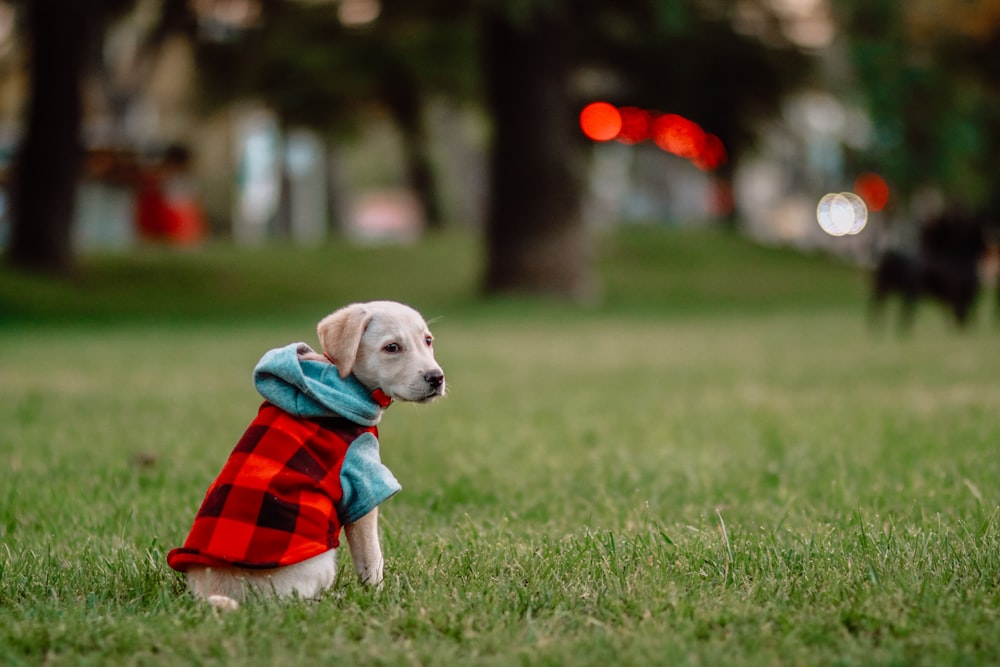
[[0, 0, 1000, 299]]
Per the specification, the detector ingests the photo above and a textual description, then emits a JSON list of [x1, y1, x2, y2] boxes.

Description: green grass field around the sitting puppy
[[0, 229, 1000, 666]]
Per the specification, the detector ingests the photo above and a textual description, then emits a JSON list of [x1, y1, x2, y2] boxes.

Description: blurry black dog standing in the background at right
[[871, 212, 987, 332]]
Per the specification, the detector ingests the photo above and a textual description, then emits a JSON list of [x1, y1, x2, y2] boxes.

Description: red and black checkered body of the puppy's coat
[[167, 403, 378, 572]]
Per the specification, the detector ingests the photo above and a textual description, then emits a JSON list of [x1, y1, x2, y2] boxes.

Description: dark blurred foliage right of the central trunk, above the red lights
[[582, 0, 812, 159]]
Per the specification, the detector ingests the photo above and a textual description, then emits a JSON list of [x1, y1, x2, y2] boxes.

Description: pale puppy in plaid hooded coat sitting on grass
[[167, 301, 446, 610]]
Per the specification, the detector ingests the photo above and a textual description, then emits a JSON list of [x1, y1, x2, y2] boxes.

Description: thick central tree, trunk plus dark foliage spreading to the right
[[472, 0, 804, 299]]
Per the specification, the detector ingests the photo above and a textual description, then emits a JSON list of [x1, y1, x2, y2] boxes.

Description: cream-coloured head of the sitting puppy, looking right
[[316, 301, 445, 403]]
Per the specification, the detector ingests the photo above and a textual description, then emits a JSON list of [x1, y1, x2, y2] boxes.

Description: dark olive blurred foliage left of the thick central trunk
[[198, 0, 476, 133]]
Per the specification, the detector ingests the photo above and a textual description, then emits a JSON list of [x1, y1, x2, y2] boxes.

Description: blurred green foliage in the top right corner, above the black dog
[[841, 0, 1000, 207]]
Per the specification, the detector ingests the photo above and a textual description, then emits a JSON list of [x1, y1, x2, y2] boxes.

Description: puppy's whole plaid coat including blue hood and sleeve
[[167, 344, 400, 572]]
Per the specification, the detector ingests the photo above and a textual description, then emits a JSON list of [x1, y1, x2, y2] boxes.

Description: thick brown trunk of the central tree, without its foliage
[[484, 16, 593, 300]]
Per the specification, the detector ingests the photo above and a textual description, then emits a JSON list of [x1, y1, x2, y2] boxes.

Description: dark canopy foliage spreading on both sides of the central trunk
[[191, 0, 808, 162]]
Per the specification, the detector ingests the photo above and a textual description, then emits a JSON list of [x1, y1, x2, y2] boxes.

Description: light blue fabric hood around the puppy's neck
[[253, 343, 382, 426]]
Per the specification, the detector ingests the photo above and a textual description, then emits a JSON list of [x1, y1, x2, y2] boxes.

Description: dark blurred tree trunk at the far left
[[7, 0, 89, 273]]
